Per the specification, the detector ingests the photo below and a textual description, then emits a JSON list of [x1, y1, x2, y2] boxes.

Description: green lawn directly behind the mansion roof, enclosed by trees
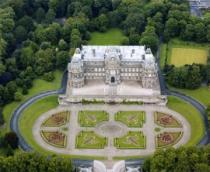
[[88, 28, 125, 45]]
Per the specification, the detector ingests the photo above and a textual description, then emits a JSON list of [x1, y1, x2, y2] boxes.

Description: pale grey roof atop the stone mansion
[[72, 45, 155, 63]]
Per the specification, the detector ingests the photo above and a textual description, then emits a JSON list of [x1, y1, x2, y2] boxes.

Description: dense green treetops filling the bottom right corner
[[143, 146, 210, 172]]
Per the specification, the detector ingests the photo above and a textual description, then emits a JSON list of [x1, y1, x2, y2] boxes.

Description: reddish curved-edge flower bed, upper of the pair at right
[[154, 112, 182, 128]]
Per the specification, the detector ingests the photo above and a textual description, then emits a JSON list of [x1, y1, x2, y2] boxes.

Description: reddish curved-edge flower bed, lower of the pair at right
[[156, 131, 183, 148]]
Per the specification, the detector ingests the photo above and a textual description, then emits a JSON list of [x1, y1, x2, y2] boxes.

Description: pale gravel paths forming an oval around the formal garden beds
[[32, 104, 191, 160]]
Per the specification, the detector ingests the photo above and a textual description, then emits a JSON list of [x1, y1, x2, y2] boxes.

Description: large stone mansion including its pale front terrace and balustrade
[[59, 46, 165, 104]]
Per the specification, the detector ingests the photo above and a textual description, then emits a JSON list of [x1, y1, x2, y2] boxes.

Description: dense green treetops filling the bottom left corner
[[0, 153, 73, 172]]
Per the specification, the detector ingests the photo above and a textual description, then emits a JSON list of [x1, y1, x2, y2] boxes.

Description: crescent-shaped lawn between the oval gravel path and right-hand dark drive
[[167, 96, 205, 146]]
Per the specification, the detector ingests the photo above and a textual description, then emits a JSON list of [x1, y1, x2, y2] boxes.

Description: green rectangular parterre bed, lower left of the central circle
[[76, 131, 108, 149]]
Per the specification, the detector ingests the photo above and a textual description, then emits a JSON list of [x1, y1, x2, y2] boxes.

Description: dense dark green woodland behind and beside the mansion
[[0, 0, 210, 125]]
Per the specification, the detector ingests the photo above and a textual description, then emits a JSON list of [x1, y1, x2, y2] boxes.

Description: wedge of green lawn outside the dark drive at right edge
[[170, 86, 210, 106]]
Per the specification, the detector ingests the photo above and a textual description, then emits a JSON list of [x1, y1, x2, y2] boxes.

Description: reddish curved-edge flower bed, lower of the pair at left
[[41, 131, 66, 148]]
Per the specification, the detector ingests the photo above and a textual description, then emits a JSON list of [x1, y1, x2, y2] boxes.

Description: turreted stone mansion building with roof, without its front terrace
[[68, 46, 158, 88]]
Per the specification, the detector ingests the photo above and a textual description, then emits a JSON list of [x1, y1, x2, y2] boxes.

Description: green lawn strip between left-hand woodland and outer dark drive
[[2, 71, 63, 136]]
